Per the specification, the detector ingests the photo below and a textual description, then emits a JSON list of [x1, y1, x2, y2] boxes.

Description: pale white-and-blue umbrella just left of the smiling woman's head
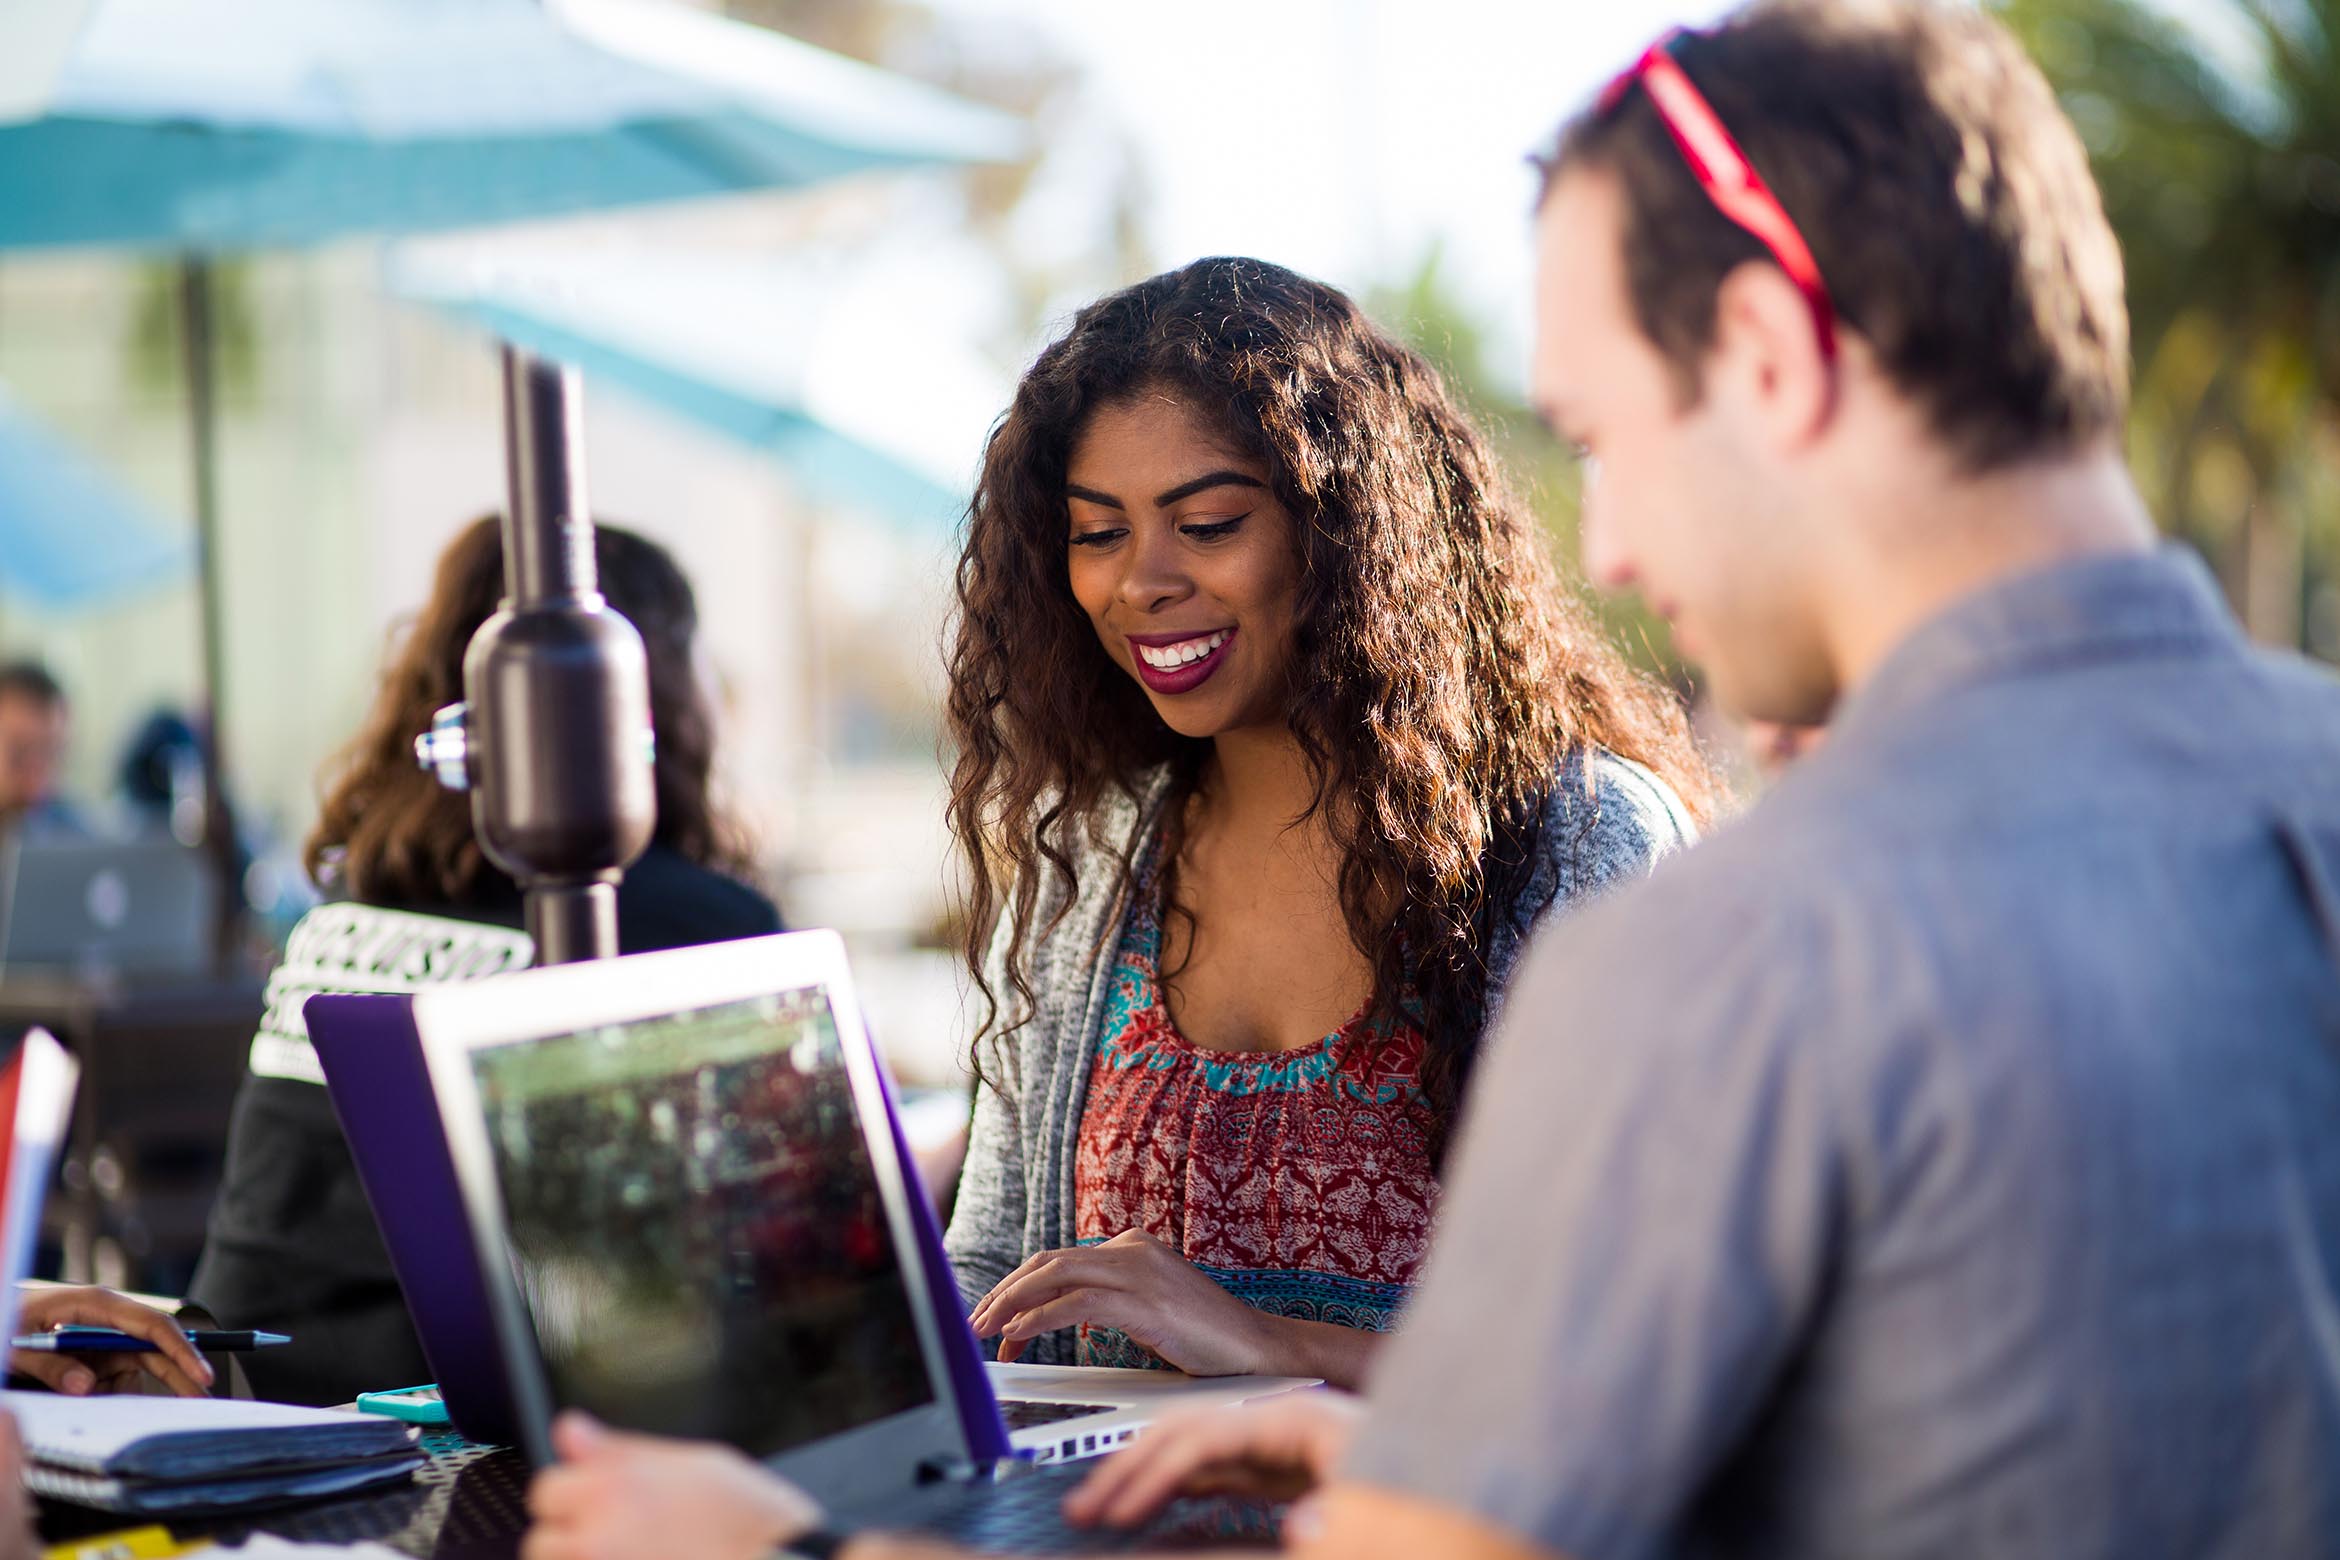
[[388, 246, 1011, 533]]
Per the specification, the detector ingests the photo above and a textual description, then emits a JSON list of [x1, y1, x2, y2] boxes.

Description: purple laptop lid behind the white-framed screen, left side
[[302, 996, 519, 1445]]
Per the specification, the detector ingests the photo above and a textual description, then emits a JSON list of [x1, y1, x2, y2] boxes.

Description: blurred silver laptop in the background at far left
[[0, 840, 218, 975]]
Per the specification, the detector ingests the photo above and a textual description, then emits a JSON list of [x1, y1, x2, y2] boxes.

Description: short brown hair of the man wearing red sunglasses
[[1544, 0, 2129, 472]]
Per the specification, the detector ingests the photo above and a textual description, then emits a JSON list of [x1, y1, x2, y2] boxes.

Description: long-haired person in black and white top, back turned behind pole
[[190, 517, 779, 1403]]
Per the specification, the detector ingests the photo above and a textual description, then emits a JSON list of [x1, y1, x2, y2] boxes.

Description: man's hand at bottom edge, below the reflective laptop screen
[[519, 1413, 821, 1560]]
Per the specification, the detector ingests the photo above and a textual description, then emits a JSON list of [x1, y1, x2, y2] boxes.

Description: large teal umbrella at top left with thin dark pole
[[0, 0, 1023, 958]]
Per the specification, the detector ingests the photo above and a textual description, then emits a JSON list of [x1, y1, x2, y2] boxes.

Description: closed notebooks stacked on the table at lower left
[[0, 1392, 424, 1516]]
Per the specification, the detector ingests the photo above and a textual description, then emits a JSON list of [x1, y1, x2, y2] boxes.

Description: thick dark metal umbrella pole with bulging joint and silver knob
[[417, 348, 658, 964]]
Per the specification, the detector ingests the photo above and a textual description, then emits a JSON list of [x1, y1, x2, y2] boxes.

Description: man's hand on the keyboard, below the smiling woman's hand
[[1065, 1392, 1364, 1527]]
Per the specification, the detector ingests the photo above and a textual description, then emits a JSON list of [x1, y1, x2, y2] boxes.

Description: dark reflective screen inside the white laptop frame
[[470, 987, 934, 1457]]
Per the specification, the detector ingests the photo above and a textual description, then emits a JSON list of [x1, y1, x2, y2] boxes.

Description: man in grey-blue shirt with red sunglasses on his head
[[529, 0, 2340, 1560]]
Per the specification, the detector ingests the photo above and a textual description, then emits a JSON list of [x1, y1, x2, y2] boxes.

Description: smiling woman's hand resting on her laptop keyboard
[[966, 1230, 1275, 1375]]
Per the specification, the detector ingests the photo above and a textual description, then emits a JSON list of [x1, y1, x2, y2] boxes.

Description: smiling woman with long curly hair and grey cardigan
[[950, 260, 1711, 1382]]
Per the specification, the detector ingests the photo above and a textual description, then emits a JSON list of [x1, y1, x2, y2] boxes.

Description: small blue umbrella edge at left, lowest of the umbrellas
[[0, 391, 194, 608]]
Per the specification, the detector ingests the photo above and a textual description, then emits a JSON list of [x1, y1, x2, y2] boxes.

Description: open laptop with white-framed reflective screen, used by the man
[[414, 931, 1313, 1546]]
